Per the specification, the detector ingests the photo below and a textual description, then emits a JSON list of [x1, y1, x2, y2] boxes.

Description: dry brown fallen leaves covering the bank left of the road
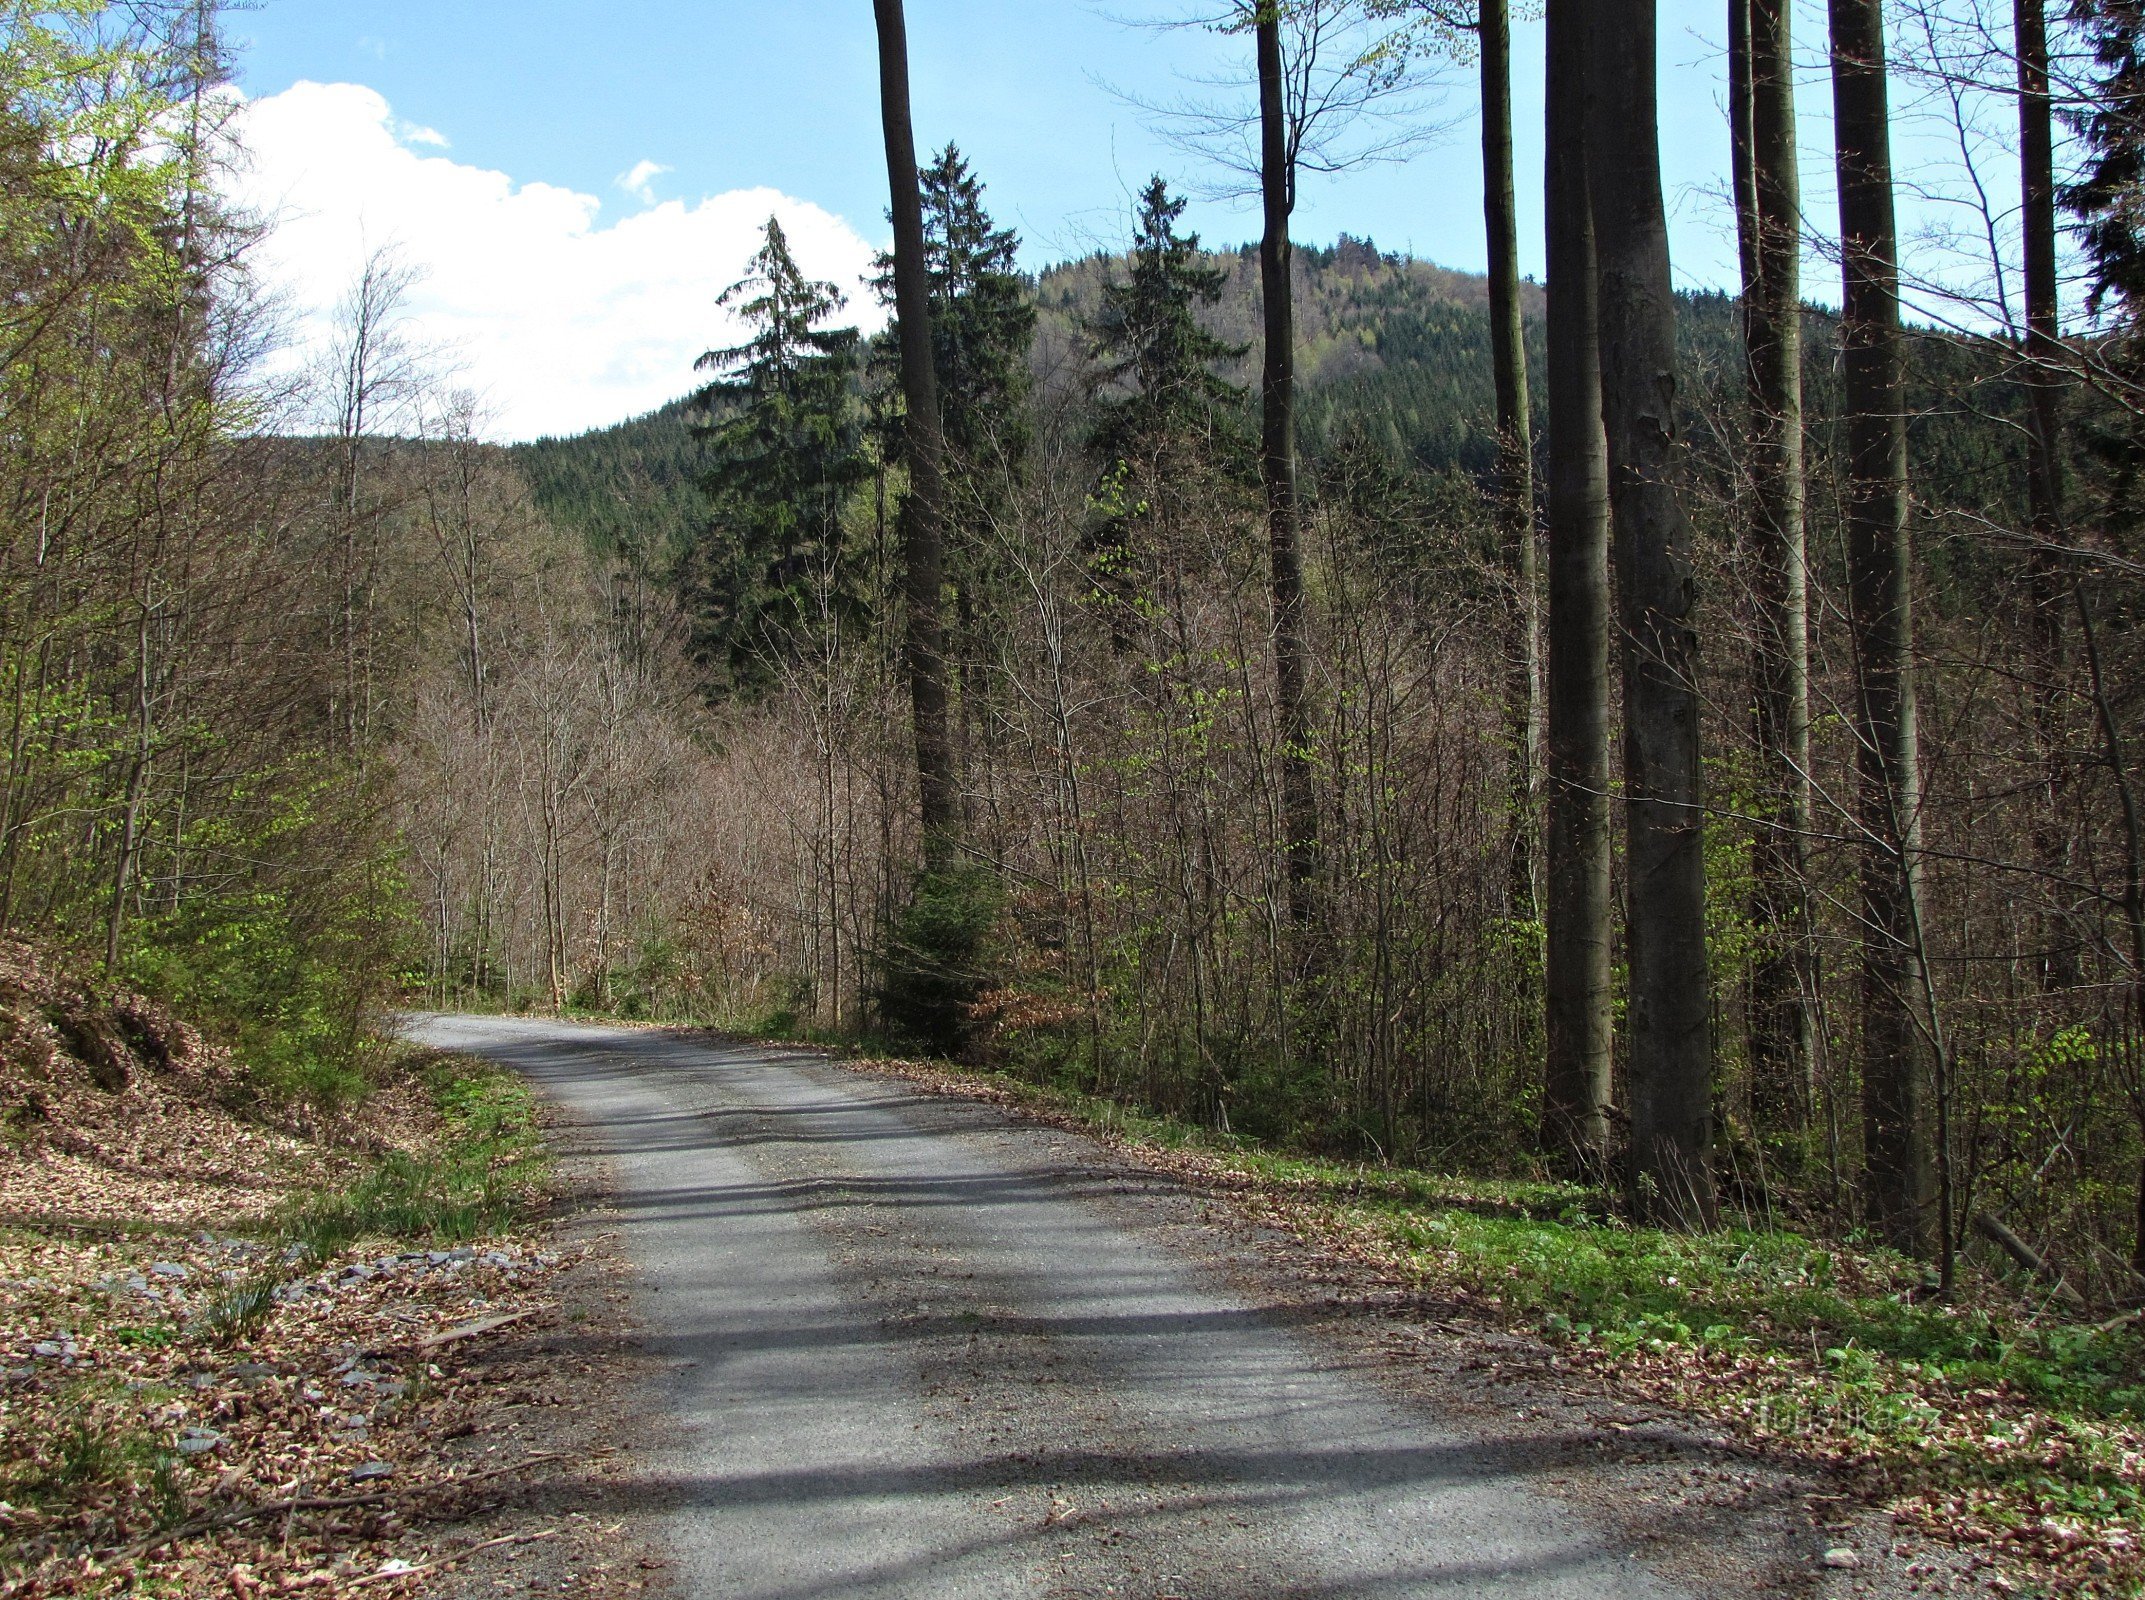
[[0, 946, 592, 1600]]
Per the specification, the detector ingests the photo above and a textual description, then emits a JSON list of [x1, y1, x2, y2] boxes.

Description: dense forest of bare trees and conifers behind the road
[[12, 0, 2145, 1304]]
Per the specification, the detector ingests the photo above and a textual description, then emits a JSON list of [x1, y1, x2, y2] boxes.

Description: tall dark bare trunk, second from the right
[[1830, 0, 1931, 1255]]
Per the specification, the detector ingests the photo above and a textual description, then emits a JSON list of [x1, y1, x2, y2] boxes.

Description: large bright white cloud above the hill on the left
[[236, 84, 884, 440]]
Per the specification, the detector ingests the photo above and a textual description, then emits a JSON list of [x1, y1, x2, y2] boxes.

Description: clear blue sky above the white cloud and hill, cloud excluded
[[232, 0, 1758, 283]]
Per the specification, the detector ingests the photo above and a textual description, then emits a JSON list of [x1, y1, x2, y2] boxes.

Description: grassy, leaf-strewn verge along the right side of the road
[[742, 1033, 2145, 1596]]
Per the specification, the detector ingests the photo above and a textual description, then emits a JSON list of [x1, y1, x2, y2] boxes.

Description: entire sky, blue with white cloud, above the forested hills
[[227, 0, 2003, 438]]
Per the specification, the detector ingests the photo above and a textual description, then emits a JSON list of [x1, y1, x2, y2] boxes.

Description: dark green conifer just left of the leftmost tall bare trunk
[[680, 217, 864, 686]]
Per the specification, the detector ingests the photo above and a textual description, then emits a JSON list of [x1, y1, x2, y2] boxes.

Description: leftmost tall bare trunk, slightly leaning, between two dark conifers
[[871, 0, 959, 864]]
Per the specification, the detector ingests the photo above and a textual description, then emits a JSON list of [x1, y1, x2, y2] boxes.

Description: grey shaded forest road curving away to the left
[[412, 1017, 1722, 1600]]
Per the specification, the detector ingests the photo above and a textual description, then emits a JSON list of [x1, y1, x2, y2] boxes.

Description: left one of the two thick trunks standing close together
[[1542, 0, 1611, 1177]]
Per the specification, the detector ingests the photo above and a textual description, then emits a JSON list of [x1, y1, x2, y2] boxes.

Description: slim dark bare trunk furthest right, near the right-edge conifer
[[2012, 0, 2079, 989]]
